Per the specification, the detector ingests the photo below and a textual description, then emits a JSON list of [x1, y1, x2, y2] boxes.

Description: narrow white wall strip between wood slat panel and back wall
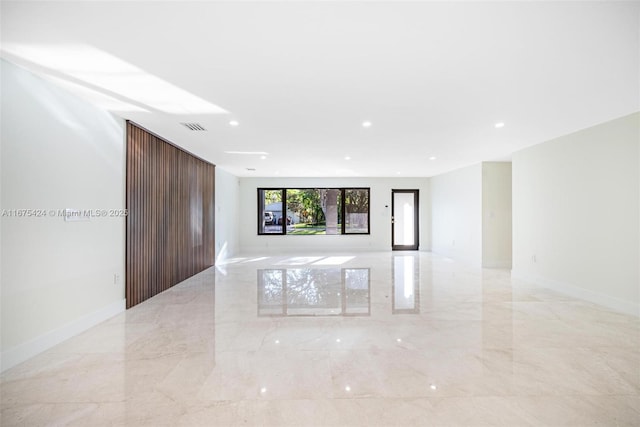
[[216, 168, 240, 263]]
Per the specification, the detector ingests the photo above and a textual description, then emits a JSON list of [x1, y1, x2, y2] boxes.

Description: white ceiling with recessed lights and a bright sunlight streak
[[1, 1, 640, 177]]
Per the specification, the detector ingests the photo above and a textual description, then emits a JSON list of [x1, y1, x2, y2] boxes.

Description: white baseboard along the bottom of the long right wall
[[511, 270, 640, 317]]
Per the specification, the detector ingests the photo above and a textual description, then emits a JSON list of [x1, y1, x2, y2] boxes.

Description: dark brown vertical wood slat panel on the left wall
[[126, 123, 215, 308]]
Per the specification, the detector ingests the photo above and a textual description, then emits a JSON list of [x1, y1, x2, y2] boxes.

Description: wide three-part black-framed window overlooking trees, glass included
[[258, 188, 370, 235]]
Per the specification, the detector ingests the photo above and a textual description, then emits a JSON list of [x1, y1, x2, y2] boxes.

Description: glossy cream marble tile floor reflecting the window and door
[[1, 252, 640, 426]]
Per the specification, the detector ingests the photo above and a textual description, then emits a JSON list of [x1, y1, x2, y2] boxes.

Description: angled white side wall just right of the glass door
[[431, 164, 482, 267]]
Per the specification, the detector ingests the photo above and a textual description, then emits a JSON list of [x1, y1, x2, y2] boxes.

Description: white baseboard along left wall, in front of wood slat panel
[[0, 299, 127, 372]]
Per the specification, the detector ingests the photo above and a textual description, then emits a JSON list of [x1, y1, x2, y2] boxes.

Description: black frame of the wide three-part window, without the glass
[[257, 187, 371, 236]]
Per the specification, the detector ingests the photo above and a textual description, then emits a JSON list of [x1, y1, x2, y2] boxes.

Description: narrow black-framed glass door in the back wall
[[391, 190, 419, 251]]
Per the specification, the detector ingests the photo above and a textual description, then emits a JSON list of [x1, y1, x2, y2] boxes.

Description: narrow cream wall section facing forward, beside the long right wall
[[482, 162, 512, 269]]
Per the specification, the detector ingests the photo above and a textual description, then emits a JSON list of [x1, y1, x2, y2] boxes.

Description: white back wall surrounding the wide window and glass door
[[240, 178, 430, 253]]
